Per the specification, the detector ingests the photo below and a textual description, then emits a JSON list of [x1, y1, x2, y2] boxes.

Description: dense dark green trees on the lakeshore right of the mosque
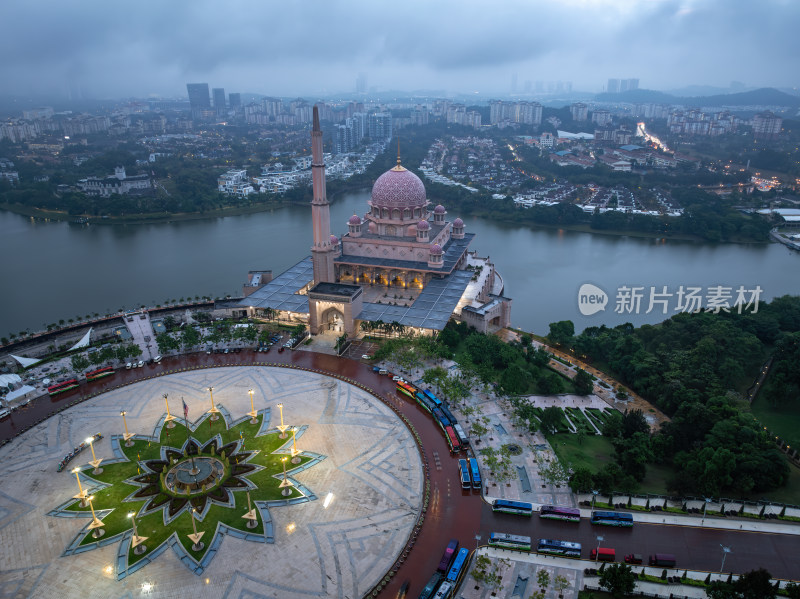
[[574, 296, 800, 497]]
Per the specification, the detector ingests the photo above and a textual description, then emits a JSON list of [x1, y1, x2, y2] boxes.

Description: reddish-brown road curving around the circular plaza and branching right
[[0, 350, 800, 597]]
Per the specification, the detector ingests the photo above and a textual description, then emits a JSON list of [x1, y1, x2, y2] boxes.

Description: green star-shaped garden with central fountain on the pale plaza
[[49, 405, 325, 579]]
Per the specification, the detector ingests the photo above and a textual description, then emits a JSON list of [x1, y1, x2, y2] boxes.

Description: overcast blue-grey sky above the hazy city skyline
[[0, 0, 800, 97]]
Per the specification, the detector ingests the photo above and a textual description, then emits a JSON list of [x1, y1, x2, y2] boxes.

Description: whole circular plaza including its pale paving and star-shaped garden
[[0, 366, 425, 598]]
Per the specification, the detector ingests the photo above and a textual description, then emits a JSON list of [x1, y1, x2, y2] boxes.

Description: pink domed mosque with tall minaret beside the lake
[[241, 106, 511, 337]]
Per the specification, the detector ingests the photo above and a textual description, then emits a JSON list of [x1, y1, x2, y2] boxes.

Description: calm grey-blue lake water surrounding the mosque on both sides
[[0, 191, 800, 336]]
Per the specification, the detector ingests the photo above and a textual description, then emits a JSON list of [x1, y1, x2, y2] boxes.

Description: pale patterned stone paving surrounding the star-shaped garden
[[0, 366, 424, 599]]
